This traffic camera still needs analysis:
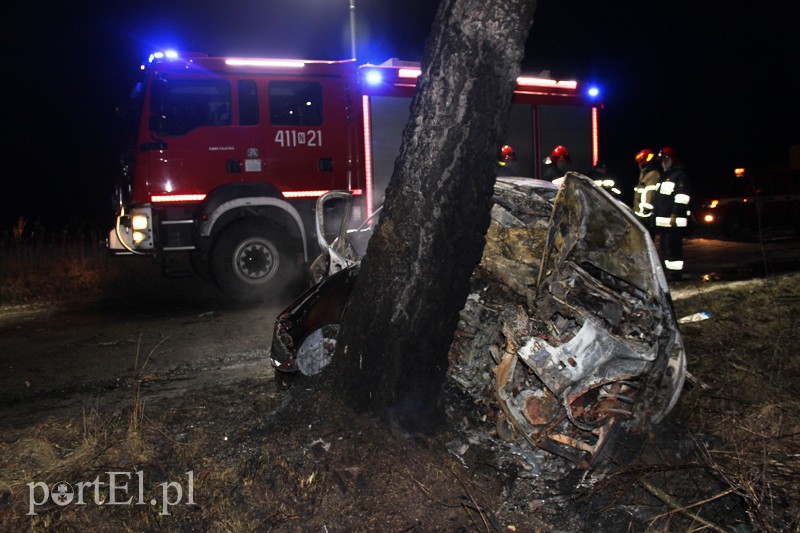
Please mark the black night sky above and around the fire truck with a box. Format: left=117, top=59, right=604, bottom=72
left=0, top=0, right=800, bottom=232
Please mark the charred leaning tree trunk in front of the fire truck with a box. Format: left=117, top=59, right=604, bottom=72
left=333, top=0, right=536, bottom=429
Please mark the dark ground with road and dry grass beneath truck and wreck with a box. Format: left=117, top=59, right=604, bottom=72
left=0, top=243, right=800, bottom=531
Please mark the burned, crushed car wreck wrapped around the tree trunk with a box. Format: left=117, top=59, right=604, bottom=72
left=271, top=173, right=686, bottom=467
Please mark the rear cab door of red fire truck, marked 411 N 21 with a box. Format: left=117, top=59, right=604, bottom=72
left=243, top=77, right=356, bottom=196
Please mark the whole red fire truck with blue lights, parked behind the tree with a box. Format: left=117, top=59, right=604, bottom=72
left=108, top=53, right=600, bottom=300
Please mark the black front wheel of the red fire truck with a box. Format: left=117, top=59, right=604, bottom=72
left=210, top=220, right=300, bottom=302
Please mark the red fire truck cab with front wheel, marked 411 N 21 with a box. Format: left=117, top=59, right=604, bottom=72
left=109, top=54, right=362, bottom=299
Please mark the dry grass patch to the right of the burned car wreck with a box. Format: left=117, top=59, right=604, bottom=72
left=676, top=275, right=800, bottom=531
